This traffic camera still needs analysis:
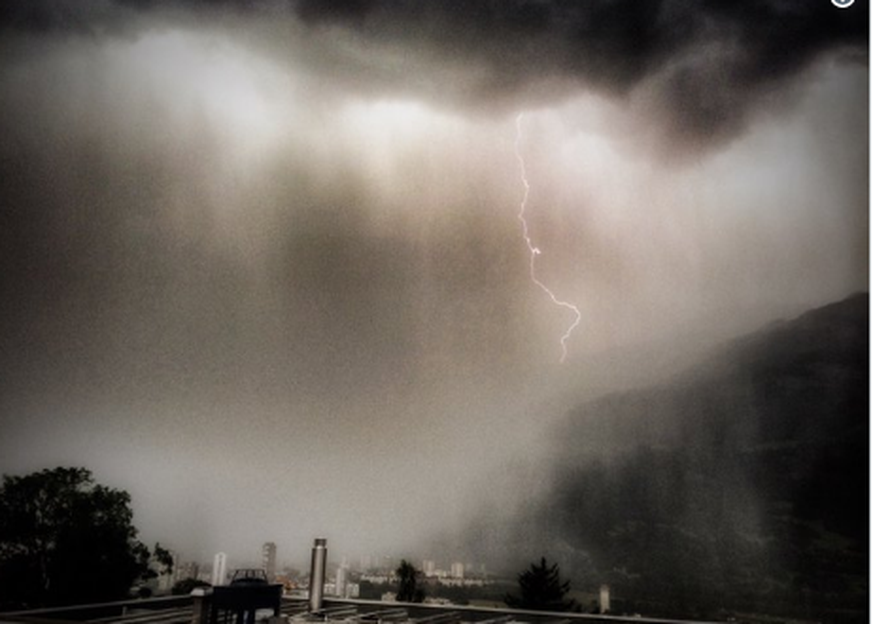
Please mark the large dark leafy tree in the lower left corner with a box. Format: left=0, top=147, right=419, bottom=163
left=0, top=468, right=154, bottom=610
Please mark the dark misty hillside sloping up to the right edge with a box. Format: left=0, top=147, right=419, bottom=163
left=480, top=294, right=869, bottom=621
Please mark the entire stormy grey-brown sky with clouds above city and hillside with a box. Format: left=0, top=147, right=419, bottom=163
left=0, top=0, right=869, bottom=567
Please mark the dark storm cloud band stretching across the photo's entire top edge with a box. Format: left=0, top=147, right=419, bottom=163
left=0, top=0, right=869, bottom=143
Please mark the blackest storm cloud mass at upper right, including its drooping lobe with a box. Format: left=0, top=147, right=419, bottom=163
left=288, top=0, right=869, bottom=141
